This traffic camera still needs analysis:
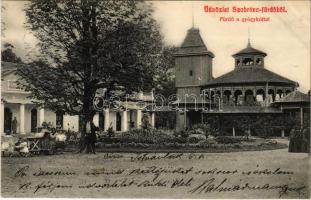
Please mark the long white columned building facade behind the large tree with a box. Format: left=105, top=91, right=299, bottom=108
left=0, top=62, right=155, bottom=134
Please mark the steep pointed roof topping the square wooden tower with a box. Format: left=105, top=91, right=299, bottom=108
left=175, top=28, right=215, bottom=58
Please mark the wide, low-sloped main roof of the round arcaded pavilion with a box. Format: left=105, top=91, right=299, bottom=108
left=207, top=67, right=298, bottom=86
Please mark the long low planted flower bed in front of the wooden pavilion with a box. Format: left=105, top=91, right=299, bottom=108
left=96, top=129, right=287, bottom=152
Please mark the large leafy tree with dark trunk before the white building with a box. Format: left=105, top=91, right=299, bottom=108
left=18, top=0, right=162, bottom=153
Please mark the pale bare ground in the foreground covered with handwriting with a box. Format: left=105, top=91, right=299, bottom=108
left=1, top=139, right=310, bottom=198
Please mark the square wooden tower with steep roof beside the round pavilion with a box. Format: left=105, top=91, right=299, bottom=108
left=174, top=27, right=214, bottom=128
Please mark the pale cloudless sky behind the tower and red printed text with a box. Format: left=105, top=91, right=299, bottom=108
left=1, top=1, right=311, bottom=92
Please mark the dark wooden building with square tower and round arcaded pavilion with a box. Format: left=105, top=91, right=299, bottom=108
left=175, top=28, right=310, bottom=134
